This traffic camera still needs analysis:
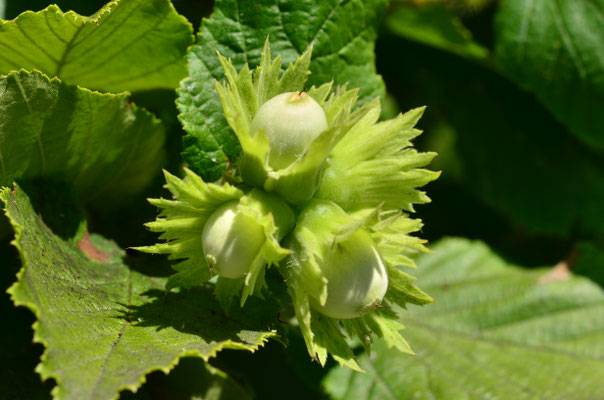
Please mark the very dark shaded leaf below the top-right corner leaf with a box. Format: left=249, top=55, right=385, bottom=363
left=448, top=67, right=604, bottom=237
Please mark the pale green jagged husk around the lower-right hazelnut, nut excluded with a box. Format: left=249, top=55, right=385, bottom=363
left=280, top=200, right=433, bottom=370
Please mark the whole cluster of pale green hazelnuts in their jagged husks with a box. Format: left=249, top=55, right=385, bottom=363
left=139, top=40, right=438, bottom=369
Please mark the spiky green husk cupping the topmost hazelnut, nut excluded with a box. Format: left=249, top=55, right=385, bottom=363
left=215, top=39, right=376, bottom=204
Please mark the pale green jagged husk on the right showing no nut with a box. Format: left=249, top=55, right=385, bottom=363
left=315, top=102, right=440, bottom=212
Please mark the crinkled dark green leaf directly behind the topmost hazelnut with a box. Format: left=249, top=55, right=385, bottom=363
left=177, top=0, right=385, bottom=181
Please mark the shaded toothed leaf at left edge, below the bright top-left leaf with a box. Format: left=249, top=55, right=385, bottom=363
left=0, top=70, right=164, bottom=202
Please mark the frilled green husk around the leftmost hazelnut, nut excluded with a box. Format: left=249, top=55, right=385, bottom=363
left=135, top=169, right=294, bottom=311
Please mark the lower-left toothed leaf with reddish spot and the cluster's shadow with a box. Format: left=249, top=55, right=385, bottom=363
left=0, top=186, right=278, bottom=400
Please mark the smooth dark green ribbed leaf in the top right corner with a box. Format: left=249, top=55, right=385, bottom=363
left=495, top=0, right=604, bottom=150
